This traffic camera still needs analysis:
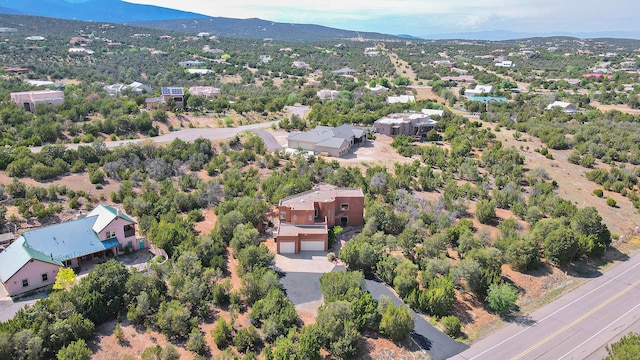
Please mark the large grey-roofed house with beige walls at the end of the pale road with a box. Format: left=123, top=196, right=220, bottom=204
left=287, top=124, right=367, bottom=157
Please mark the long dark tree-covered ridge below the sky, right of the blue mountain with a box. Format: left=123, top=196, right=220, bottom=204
left=128, top=17, right=406, bottom=41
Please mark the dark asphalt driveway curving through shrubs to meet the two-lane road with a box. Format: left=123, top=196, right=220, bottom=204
left=366, top=280, right=468, bottom=360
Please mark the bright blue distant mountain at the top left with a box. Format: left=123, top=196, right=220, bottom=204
left=0, top=0, right=205, bottom=23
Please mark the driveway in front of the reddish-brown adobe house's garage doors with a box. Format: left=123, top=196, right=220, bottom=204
left=275, top=252, right=344, bottom=314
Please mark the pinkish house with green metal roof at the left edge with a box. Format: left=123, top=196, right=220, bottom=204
left=0, top=205, right=139, bottom=296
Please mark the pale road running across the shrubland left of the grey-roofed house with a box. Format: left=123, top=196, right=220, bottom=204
left=31, top=121, right=278, bottom=153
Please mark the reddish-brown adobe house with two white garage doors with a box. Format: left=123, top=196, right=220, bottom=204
left=275, top=184, right=364, bottom=254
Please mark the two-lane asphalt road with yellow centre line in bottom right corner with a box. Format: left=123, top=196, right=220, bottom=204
left=453, top=254, right=640, bottom=360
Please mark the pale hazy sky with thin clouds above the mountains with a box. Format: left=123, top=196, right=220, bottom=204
left=125, top=0, right=640, bottom=36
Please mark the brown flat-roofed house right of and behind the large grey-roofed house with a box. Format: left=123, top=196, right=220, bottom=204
left=373, top=113, right=439, bottom=137
